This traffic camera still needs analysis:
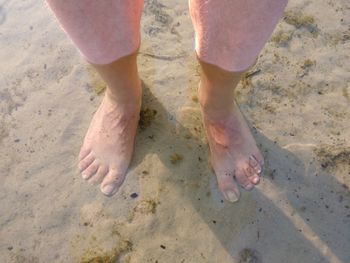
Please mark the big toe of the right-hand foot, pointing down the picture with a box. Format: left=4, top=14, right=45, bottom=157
left=216, top=173, right=240, bottom=203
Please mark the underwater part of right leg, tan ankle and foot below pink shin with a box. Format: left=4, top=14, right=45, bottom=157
left=199, top=62, right=264, bottom=202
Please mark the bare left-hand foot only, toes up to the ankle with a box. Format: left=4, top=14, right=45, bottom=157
left=79, top=92, right=140, bottom=196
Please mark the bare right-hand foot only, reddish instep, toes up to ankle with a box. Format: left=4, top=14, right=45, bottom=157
left=202, top=94, right=264, bottom=202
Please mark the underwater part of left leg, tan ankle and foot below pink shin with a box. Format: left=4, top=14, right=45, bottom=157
left=79, top=53, right=141, bottom=195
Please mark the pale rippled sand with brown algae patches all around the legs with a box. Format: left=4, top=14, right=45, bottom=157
left=0, top=0, right=350, bottom=263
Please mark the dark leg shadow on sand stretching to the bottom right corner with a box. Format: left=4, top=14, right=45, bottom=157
left=132, top=84, right=350, bottom=262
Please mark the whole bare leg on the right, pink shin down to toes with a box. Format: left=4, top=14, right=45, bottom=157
left=189, top=0, right=288, bottom=202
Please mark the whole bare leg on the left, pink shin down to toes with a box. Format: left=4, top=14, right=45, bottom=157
left=47, top=0, right=143, bottom=195
